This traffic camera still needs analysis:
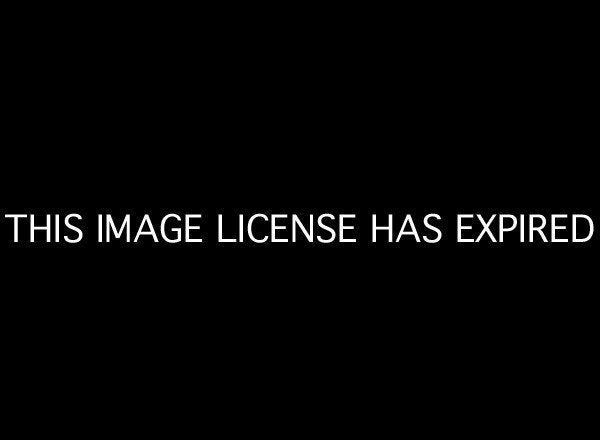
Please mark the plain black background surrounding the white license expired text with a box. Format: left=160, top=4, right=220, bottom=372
left=1, top=5, right=598, bottom=433
